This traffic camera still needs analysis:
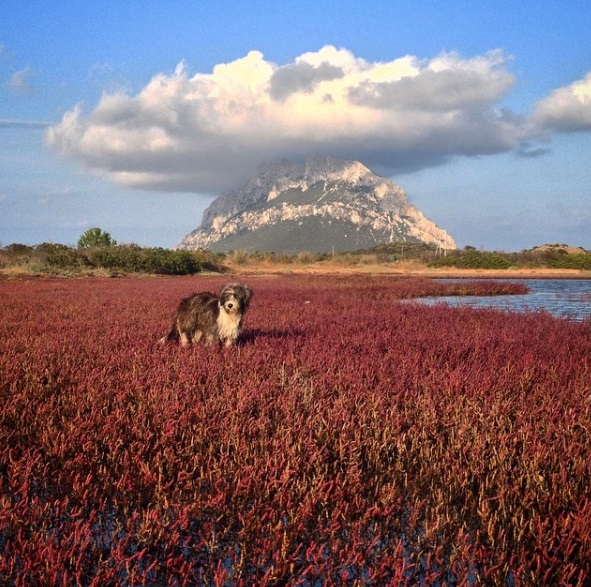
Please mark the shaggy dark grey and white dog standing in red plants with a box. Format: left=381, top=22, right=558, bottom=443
left=160, top=283, right=253, bottom=348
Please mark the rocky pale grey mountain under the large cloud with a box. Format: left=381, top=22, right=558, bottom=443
left=177, top=157, right=456, bottom=253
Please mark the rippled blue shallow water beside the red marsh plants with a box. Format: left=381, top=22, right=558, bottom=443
left=416, top=279, right=591, bottom=321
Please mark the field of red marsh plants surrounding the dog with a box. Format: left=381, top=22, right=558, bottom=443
left=0, top=276, right=591, bottom=586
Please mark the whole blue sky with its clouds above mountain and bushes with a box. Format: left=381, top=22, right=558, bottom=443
left=0, top=0, right=591, bottom=251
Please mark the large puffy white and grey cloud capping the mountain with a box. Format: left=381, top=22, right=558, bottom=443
left=45, top=46, right=568, bottom=193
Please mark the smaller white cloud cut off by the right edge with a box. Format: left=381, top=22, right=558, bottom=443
left=534, top=72, right=591, bottom=132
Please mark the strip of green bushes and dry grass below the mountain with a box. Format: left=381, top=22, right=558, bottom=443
left=0, top=228, right=591, bottom=276
